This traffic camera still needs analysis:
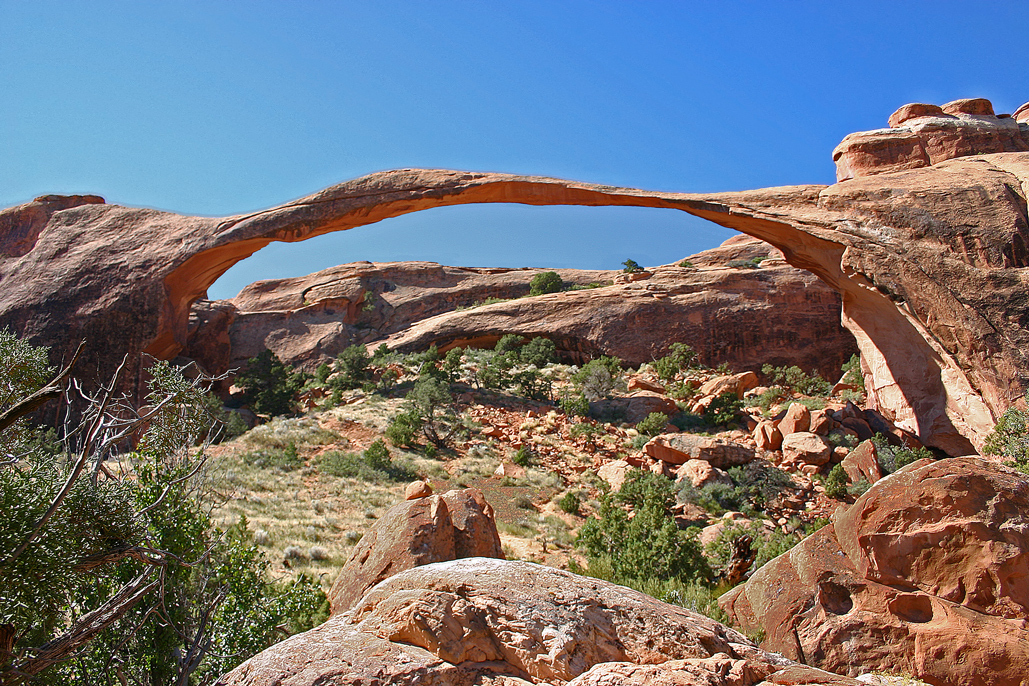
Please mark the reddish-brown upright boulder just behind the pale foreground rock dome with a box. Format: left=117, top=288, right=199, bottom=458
left=328, top=483, right=504, bottom=614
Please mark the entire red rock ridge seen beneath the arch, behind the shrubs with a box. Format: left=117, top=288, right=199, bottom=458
left=182, top=237, right=857, bottom=376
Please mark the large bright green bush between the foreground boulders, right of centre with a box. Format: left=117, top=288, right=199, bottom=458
left=575, top=470, right=711, bottom=583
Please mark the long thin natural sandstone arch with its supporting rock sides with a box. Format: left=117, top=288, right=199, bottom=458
left=0, top=97, right=1029, bottom=455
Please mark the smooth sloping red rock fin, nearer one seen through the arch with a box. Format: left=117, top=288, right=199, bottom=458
left=376, top=254, right=853, bottom=376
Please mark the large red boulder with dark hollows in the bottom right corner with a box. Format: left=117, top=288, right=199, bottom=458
left=720, top=458, right=1029, bottom=686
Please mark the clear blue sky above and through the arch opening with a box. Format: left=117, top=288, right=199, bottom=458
left=0, top=0, right=1029, bottom=297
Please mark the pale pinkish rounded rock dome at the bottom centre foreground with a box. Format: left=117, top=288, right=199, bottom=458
left=218, top=557, right=857, bottom=686
